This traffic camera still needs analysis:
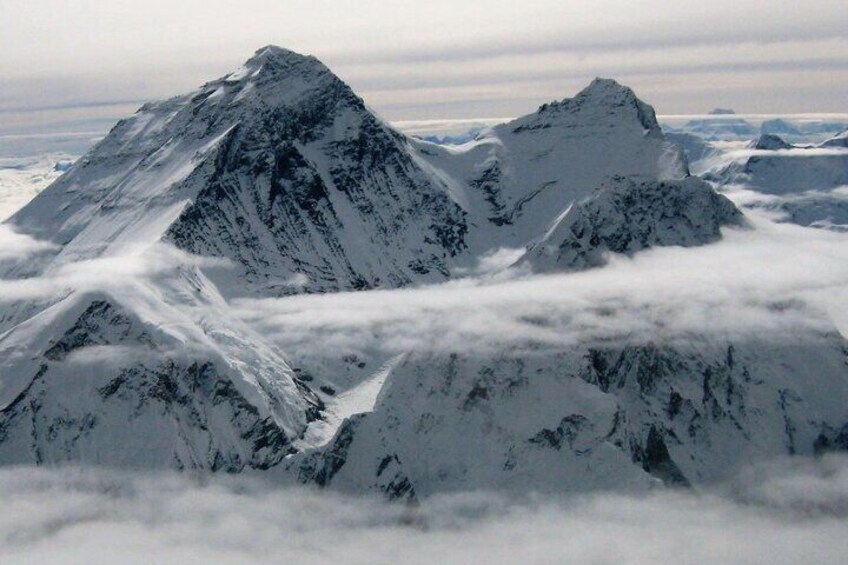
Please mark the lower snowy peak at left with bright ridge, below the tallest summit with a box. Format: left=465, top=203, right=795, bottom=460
left=0, top=273, right=321, bottom=472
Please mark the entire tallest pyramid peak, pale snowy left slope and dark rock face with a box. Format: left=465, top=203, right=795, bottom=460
left=6, top=47, right=465, bottom=293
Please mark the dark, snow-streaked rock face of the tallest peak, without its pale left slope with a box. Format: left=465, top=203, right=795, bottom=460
left=159, top=49, right=467, bottom=293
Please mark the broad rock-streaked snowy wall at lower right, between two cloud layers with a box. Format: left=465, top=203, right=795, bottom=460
left=286, top=333, right=848, bottom=498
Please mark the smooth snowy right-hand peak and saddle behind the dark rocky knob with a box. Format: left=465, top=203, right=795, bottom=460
left=416, top=79, right=688, bottom=252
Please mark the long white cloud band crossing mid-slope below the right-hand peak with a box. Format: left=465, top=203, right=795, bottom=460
left=233, top=217, right=848, bottom=356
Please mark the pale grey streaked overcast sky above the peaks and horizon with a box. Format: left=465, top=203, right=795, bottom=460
left=0, top=0, right=848, bottom=132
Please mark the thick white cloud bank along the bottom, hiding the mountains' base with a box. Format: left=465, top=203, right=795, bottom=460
left=0, top=456, right=848, bottom=565
